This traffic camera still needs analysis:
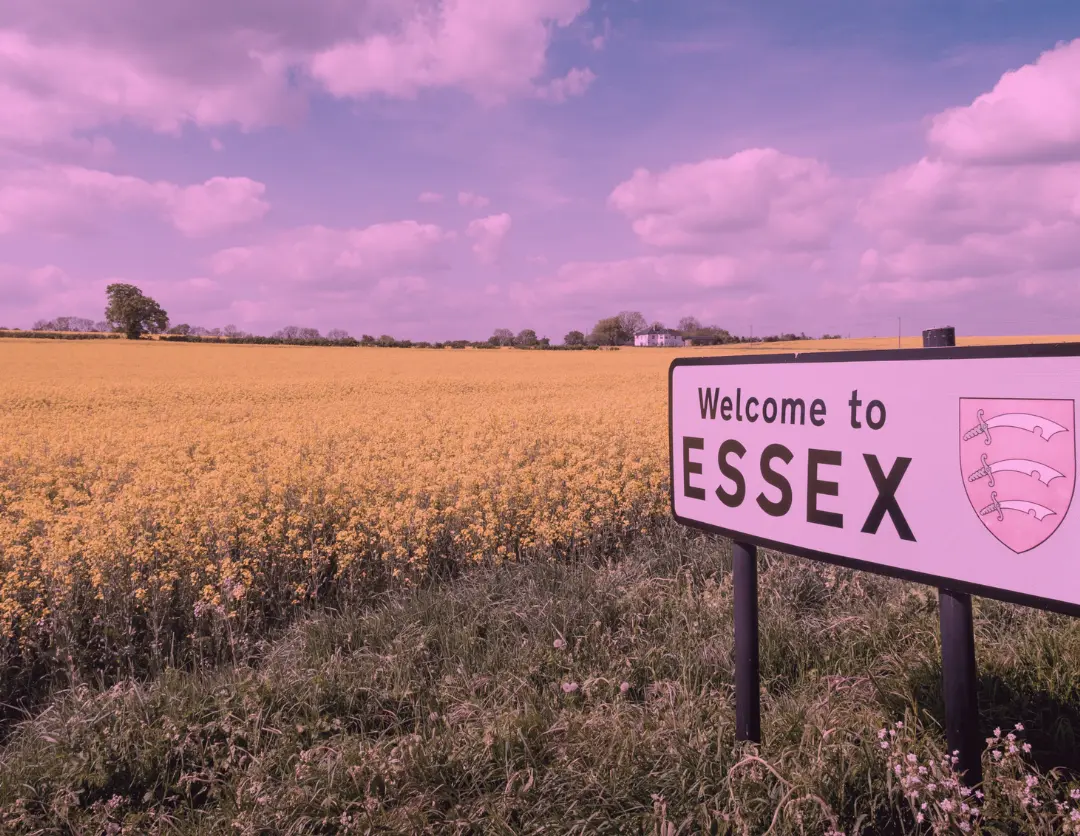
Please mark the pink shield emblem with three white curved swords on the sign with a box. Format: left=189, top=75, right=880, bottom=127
left=958, top=397, right=1077, bottom=554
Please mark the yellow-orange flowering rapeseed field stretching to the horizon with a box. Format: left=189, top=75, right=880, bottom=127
left=0, top=339, right=1071, bottom=686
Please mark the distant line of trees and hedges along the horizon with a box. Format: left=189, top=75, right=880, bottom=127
left=8, top=283, right=840, bottom=350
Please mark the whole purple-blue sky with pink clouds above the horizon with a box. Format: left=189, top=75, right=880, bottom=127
left=0, top=0, right=1080, bottom=342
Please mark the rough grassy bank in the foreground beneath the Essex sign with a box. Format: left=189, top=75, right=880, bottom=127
left=0, top=524, right=1080, bottom=836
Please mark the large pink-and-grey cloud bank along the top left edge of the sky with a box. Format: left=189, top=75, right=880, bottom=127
left=0, top=0, right=589, bottom=149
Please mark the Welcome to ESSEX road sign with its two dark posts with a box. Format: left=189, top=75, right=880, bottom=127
left=669, top=336, right=1080, bottom=783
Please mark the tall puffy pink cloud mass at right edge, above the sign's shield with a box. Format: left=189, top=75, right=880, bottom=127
left=858, top=40, right=1080, bottom=298
